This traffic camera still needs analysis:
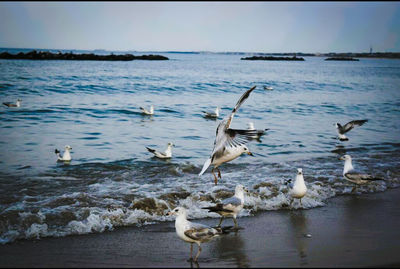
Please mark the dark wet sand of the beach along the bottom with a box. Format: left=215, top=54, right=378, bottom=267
left=0, top=188, right=400, bottom=268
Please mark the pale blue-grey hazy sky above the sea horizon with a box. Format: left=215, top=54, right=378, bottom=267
left=0, top=1, right=400, bottom=53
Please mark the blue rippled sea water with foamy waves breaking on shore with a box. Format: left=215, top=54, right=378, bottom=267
left=0, top=53, right=400, bottom=243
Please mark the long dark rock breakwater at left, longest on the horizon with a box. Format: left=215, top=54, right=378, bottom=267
left=0, top=50, right=169, bottom=61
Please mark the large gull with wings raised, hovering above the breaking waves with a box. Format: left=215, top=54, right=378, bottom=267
left=199, top=86, right=257, bottom=185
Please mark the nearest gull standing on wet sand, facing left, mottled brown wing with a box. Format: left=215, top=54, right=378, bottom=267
left=167, top=207, right=230, bottom=262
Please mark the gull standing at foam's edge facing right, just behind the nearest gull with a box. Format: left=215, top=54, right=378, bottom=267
left=203, top=184, right=249, bottom=229
